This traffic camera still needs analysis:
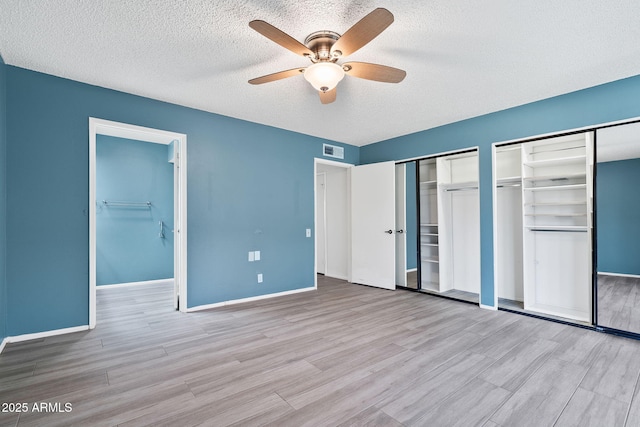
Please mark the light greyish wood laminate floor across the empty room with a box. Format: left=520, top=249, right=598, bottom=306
left=0, top=276, right=640, bottom=427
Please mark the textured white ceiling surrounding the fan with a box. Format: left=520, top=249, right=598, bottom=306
left=0, top=0, right=640, bottom=145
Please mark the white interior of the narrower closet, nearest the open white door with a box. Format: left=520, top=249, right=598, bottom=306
left=418, top=151, right=480, bottom=302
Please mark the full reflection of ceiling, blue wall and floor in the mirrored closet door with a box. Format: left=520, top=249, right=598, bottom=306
left=596, top=123, right=640, bottom=333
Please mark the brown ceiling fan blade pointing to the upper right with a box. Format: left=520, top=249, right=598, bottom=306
left=331, top=7, right=393, bottom=57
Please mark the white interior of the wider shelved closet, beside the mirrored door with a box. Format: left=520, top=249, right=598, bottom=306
left=495, top=133, right=593, bottom=322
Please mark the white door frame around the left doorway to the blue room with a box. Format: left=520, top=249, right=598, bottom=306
left=89, top=117, right=187, bottom=329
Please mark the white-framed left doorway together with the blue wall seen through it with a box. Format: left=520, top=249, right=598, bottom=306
left=88, top=118, right=187, bottom=328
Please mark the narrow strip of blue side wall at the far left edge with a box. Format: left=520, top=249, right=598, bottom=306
left=0, top=56, right=8, bottom=343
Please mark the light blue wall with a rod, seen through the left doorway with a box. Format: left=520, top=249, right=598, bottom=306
left=96, top=135, right=174, bottom=286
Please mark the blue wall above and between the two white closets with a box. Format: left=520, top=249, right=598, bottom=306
left=360, top=76, right=640, bottom=306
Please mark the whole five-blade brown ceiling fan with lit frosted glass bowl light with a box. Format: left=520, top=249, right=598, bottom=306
left=249, top=8, right=407, bottom=104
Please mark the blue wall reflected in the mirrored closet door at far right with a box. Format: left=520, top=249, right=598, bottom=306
left=596, top=159, right=640, bottom=275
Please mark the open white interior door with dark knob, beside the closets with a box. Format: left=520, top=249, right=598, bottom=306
left=351, top=162, right=396, bottom=289
